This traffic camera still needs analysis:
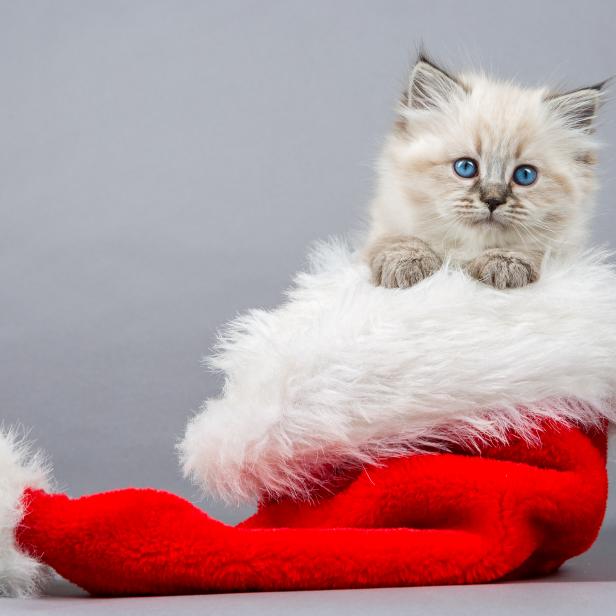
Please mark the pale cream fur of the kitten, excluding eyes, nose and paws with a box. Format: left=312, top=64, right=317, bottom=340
left=368, top=70, right=600, bottom=262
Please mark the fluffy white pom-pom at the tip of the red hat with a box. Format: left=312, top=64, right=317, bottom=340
left=0, top=430, right=50, bottom=597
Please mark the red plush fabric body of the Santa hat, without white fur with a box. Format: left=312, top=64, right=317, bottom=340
left=16, top=426, right=607, bottom=595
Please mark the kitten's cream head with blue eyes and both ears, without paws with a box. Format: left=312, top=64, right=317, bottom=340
left=382, top=61, right=599, bottom=255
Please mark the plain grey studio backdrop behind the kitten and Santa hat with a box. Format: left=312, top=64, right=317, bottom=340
left=0, top=0, right=616, bottom=520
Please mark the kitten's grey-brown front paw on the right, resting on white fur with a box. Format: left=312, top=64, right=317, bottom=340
left=467, top=249, right=539, bottom=289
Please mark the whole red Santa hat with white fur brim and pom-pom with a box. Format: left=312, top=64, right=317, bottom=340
left=0, top=247, right=616, bottom=595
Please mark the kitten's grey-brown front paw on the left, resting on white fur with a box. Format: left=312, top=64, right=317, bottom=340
left=365, top=235, right=443, bottom=288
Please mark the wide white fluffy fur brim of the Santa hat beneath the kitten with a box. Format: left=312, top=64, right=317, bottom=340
left=179, top=238, right=616, bottom=502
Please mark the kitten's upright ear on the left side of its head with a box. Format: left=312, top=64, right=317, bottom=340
left=402, top=54, right=466, bottom=111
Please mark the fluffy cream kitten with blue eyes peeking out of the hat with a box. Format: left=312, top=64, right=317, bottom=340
left=364, top=55, right=603, bottom=288
